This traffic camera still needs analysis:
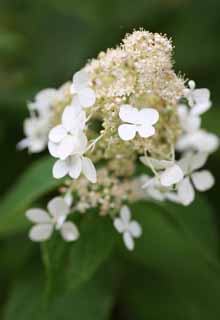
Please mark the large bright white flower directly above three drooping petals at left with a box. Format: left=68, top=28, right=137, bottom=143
left=48, top=106, right=87, bottom=160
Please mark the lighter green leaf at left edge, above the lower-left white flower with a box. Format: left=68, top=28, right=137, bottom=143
left=0, top=158, right=60, bottom=236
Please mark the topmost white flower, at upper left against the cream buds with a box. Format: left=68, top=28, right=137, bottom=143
left=70, top=70, right=96, bottom=108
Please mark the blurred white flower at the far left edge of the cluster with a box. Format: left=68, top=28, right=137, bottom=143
left=17, top=117, right=49, bottom=153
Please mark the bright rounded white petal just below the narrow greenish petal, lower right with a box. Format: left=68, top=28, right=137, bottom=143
left=160, top=164, right=183, bottom=187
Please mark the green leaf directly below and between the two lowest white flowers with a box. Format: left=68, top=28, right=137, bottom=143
left=43, top=211, right=115, bottom=295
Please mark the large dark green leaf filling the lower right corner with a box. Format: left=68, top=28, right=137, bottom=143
left=120, top=199, right=220, bottom=320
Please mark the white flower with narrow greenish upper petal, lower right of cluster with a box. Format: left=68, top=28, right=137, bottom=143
left=140, top=157, right=183, bottom=188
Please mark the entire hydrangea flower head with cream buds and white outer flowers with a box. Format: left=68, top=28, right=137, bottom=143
left=18, top=30, right=219, bottom=250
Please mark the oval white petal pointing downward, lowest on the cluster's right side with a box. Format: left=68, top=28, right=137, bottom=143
left=177, top=177, right=195, bottom=206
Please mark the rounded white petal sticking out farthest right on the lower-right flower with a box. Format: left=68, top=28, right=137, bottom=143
left=192, top=170, right=215, bottom=191
